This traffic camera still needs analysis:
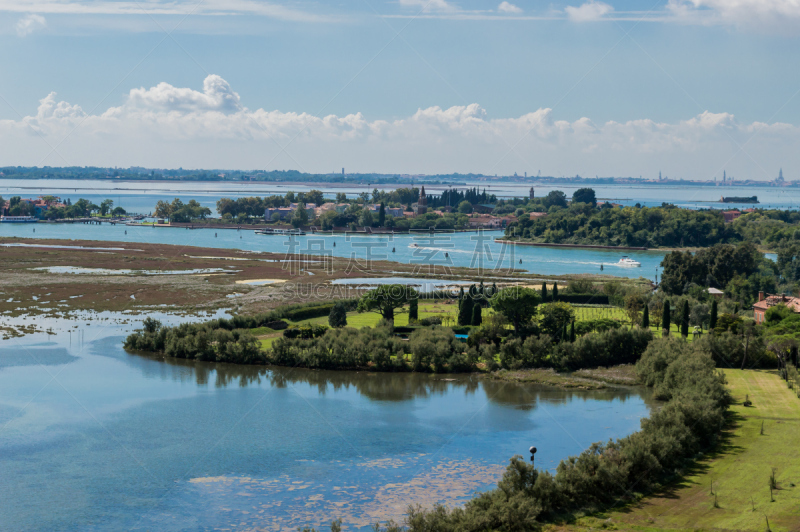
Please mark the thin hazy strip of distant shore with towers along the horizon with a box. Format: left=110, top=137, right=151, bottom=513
left=0, top=166, right=800, bottom=187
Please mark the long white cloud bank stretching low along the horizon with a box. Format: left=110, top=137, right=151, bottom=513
left=0, top=76, right=800, bottom=179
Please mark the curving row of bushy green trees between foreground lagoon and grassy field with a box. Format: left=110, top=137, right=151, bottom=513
left=310, top=338, right=731, bottom=532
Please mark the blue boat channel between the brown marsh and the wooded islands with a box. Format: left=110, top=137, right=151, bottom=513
left=0, top=223, right=664, bottom=279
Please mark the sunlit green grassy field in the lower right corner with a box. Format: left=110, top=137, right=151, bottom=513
left=564, top=370, right=800, bottom=532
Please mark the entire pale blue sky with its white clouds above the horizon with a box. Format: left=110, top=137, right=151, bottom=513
left=0, top=0, right=800, bottom=179
